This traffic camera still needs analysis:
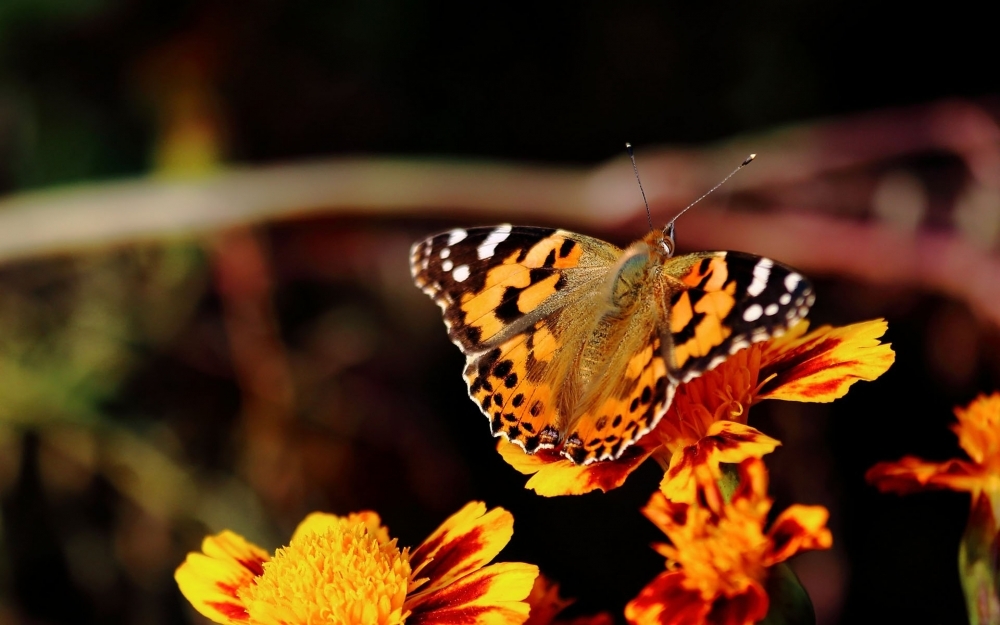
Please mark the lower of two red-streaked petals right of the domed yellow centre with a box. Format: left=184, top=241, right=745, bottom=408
left=406, top=562, right=538, bottom=625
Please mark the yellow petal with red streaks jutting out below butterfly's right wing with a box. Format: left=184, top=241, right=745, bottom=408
left=757, top=319, right=896, bottom=402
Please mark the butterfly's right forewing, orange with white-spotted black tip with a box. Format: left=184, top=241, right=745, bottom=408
left=664, top=252, right=815, bottom=382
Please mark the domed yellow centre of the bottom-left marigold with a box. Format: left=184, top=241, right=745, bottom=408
left=240, top=519, right=410, bottom=625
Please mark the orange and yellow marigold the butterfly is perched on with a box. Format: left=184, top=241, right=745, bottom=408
left=497, top=319, right=895, bottom=497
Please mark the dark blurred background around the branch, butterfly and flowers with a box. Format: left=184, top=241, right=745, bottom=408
left=0, top=0, right=1000, bottom=624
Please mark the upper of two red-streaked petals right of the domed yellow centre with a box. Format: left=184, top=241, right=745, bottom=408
left=410, top=501, right=512, bottom=596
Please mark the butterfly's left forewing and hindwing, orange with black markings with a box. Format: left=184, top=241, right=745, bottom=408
left=410, top=225, right=621, bottom=453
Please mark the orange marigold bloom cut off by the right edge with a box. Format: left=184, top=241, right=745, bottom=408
left=866, top=393, right=1000, bottom=510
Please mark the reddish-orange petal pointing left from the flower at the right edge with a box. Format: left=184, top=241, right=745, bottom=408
left=865, top=456, right=989, bottom=494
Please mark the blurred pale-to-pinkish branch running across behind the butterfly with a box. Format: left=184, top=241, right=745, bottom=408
left=0, top=102, right=1000, bottom=323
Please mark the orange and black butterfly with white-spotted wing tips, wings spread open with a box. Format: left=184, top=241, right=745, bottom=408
left=410, top=222, right=814, bottom=464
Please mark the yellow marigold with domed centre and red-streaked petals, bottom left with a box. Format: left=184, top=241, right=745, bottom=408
left=174, top=502, right=538, bottom=625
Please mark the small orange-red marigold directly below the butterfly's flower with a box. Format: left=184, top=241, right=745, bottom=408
left=625, top=458, right=833, bottom=625
